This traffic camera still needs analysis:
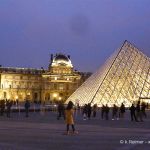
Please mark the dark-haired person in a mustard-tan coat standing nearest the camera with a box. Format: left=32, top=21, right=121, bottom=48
left=65, top=101, right=75, bottom=134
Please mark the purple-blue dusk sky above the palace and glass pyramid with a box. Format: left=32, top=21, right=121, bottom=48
left=0, top=0, right=150, bottom=72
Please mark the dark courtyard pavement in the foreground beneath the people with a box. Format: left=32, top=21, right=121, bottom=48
left=0, top=111, right=150, bottom=150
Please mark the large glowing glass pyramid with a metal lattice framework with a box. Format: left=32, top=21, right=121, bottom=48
left=66, top=41, right=150, bottom=107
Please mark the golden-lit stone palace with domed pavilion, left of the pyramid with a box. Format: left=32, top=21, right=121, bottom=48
left=0, top=54, right=81, bottom=102
